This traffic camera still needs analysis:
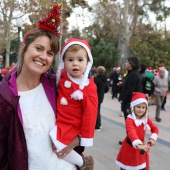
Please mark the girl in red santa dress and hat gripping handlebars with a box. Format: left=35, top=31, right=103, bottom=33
left=116, top=92, right=158, bottom=170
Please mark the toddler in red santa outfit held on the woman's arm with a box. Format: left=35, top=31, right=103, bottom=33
left=50, top=38, right=98, bottom=170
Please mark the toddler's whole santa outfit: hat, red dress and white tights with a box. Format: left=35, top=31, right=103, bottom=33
left=50, top=38, right=98, bottom=166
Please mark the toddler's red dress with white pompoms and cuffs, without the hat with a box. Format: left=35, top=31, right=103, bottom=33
left=56, top=70, right=98, bottom=146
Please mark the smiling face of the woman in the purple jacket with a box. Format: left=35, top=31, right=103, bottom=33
left=22, top=36, right=54, bottom=75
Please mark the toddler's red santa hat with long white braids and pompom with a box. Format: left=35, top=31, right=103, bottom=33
left=56, top=38, right=93, bottom=100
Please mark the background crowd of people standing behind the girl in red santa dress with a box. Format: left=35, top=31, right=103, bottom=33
left=110, top=61, right=169, bottom=122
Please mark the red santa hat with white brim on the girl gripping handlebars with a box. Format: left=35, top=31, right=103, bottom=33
left=130, top=92, right=148, bottom=108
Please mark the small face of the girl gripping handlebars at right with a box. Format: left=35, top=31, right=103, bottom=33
left=134, top=103, right=147, bottom=119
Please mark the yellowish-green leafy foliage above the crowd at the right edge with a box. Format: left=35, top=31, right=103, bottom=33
left=129, top=25, right=170, bottom=69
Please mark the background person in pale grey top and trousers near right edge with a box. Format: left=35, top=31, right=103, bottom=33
left=153, top=67, right=168, bottom=122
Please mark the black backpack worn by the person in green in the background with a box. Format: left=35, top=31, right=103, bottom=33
left=143, top=77, right=155, bottom=94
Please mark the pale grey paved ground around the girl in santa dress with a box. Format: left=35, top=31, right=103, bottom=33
left=85, top=89, right=170, bottom=170
